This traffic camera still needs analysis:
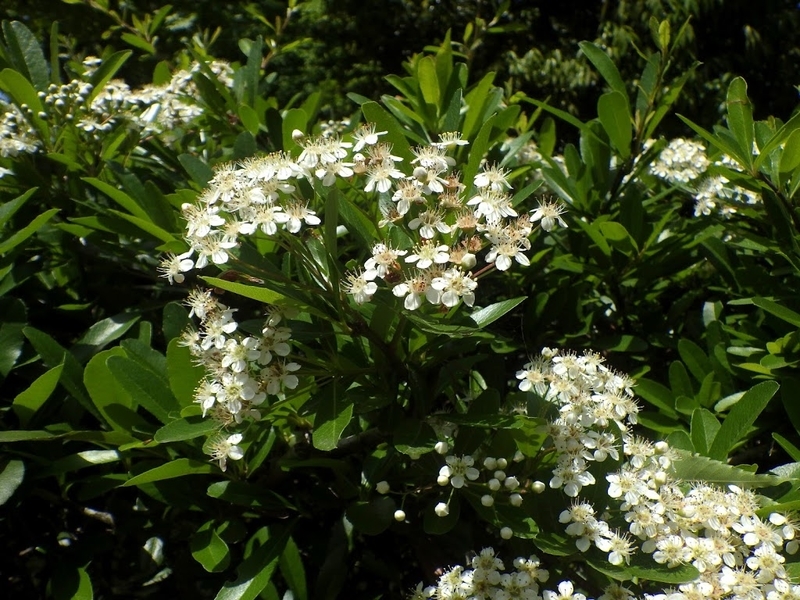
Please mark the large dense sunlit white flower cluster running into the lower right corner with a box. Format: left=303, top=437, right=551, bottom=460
left=517, top=349, right=800, bottom=600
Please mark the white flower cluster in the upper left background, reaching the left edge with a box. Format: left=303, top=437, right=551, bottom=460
left=0, top=57, right=233, bottom=157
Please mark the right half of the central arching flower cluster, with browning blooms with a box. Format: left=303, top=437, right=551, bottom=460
left=345, top=129, right=566, bottom=310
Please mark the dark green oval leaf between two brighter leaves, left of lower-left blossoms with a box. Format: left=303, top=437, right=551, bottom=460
left=106, top=356, right=181, bottom=424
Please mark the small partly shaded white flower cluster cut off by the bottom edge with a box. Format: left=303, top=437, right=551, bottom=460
left=409, top=548, right=552, bottom=600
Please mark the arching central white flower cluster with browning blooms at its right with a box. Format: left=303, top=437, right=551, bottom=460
left=161, top=124, right=566, bottom=310
